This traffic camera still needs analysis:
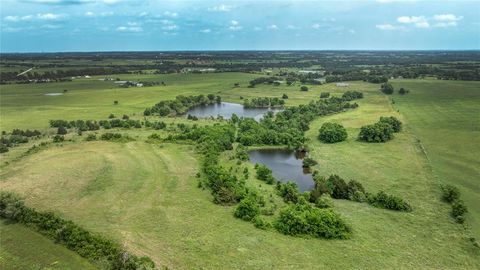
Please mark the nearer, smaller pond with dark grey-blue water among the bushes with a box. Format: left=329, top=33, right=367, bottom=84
left=248, top=149, right=314, bottom=192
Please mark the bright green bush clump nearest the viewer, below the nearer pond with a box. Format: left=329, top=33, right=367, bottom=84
left=275, top=203, right=351, bottom=239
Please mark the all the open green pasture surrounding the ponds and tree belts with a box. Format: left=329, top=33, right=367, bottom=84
left=0, top=51, right=480, bottom=269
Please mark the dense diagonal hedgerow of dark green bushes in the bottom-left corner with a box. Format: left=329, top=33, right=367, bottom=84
left=0, top=191, right=155, bottom=270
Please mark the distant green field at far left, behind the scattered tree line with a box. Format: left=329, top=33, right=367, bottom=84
left=0, top=73, right=256, bottom=131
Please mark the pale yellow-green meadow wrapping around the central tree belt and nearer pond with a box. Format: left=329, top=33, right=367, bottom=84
left=0, top=79, right=480, bottom=269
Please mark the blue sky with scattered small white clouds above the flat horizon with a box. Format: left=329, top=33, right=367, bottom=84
left=0, top=0, right=480, bottom=52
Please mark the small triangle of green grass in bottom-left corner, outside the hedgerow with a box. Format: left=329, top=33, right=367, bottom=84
left=0, top=220, right=96, bottom=270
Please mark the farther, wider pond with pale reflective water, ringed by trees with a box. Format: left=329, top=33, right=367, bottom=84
left=187, top=102, right=277, bottom=121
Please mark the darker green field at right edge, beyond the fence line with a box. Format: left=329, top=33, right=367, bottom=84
left=392, top=80, right=480, bottom=238
